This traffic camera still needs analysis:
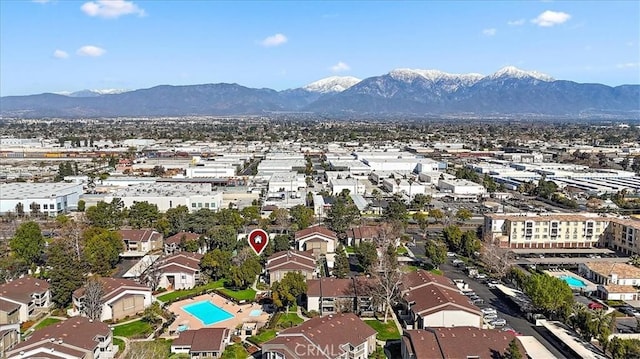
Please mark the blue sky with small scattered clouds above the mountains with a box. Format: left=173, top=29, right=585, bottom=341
left=0, top=0, right=640, bottom=96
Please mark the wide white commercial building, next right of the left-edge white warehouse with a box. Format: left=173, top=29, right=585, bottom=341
left=104, top=182, right=223, bottom=212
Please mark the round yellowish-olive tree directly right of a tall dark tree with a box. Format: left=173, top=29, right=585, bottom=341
left=82, top=227, right=124, bottom=276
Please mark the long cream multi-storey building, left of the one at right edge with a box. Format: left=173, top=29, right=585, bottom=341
left=484, top=213, right=611, bottom=248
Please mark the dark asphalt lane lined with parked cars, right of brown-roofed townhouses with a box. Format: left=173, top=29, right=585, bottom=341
left=440, top=259, right=566, bottom=358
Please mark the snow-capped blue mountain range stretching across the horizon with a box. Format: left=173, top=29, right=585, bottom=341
left=0, top=66, right=640, bottom=119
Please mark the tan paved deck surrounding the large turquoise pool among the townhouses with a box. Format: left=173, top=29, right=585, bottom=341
left=168, top=294, right=269, bottom=333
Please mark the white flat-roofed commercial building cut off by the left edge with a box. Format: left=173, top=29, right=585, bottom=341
left=0, top=182, right=83, bottom=217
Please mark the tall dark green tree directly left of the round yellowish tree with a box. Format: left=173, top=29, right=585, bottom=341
left=47, top=237, right=86, bottom=308
